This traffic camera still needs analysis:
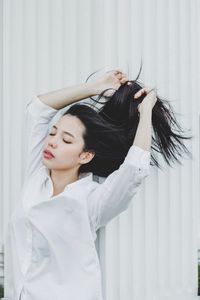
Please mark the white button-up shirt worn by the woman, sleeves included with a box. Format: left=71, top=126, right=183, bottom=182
left=3, top=97, right=150, bottom=300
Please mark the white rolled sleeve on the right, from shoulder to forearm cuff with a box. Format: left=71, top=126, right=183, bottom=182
left=88, top=145, right=150, bottom=230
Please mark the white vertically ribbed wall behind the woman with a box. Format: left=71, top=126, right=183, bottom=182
left=0, top=0, right=200, bottom=300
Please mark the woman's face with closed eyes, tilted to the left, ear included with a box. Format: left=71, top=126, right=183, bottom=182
left=43, top=114, right=93, bottom=170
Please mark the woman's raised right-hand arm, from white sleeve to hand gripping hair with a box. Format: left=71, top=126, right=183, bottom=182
left=88, top=86, right=157, bottom=231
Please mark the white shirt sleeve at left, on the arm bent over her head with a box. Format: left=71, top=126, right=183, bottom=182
left=24, top=96, right=58, bottom=180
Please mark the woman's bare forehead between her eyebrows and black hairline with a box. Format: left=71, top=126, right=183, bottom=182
left=53, top=114, right=85, bottom=138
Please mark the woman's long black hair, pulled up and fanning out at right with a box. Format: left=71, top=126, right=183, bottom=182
left=64, top=68, right=191, bottom=177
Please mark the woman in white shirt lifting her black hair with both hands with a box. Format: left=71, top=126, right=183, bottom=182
left=4, top=70, right=189, bottom=300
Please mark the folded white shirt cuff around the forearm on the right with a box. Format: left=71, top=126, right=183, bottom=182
left=124, top=145, right=151, bottom=169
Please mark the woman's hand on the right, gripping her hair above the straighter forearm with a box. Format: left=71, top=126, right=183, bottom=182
left=134, top=87, right=157, bottom=114
